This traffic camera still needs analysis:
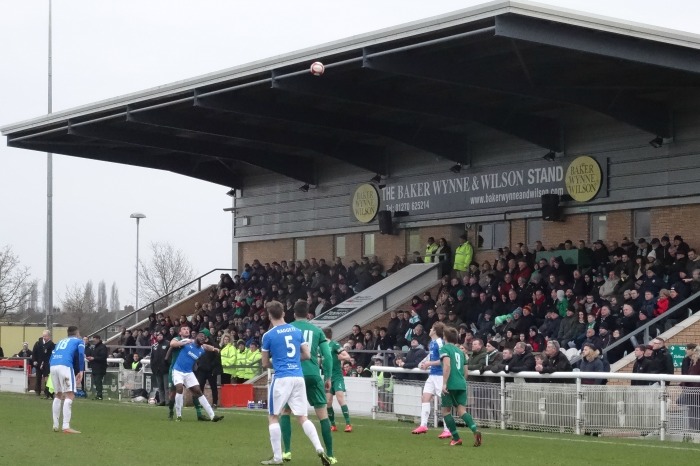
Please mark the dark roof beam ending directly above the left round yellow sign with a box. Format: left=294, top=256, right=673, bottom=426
left=127, top=105, right=387, bottom=175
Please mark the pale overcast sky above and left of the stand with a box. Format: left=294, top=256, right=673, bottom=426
left=0, top=0, right=700, bottom=307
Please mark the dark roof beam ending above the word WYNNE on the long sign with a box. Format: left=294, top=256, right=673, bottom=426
left=195, top=93, right=469, bottom=163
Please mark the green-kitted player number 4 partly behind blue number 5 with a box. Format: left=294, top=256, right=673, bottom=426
left=280, top=300, right=338, bottom=464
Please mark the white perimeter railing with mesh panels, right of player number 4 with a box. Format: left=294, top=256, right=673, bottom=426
left=282, top=366, right=700, bottom=443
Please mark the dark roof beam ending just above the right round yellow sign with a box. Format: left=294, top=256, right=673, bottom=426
left=363, top=45, right=671, bottom=137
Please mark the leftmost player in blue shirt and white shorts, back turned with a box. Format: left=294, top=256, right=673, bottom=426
left=49, top=325, right=85, bottom=434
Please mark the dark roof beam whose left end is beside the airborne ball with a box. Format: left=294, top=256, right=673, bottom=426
left=272, top=62, right=563, bottom=152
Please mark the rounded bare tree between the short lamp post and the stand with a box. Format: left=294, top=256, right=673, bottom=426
left=139, top=243, right=195, bottom=309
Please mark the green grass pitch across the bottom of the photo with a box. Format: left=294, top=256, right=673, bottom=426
left=0, top=393, right=700, bottom=466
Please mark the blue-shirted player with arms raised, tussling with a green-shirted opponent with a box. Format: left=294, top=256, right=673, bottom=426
left=170, top=333, right=224, bottom=422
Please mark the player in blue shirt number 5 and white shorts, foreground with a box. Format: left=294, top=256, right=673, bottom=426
left=261, top=301, right=331, bottom=466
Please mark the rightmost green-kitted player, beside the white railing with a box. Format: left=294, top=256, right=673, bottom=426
left=440, top=327, right=481, bottom=447
